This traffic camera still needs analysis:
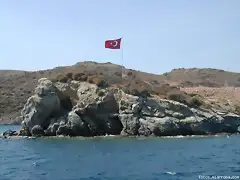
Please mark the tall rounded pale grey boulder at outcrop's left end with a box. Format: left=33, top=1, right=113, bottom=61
left=21, top=78, right=72, bottom=134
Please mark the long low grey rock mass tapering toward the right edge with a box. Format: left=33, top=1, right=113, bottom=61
left=119, top=94, right=240, bottom=136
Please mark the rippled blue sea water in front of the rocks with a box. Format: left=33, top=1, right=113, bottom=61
left=0, top=125, right=240, bottom=180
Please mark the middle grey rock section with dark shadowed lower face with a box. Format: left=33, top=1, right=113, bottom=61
left=73, top=82, right=122, bottom=136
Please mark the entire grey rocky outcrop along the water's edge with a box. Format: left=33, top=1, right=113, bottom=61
left=21, top=78, right=240, bottom=136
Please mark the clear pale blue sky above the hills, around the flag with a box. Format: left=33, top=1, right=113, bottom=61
left=0, top=0, right=240, bottom=74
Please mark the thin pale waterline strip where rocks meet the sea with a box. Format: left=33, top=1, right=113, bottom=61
left=0, top=133, right=240, bottom=140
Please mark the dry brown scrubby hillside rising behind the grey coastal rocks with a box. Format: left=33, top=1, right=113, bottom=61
left=0, top=62, right=240, bottom=123
